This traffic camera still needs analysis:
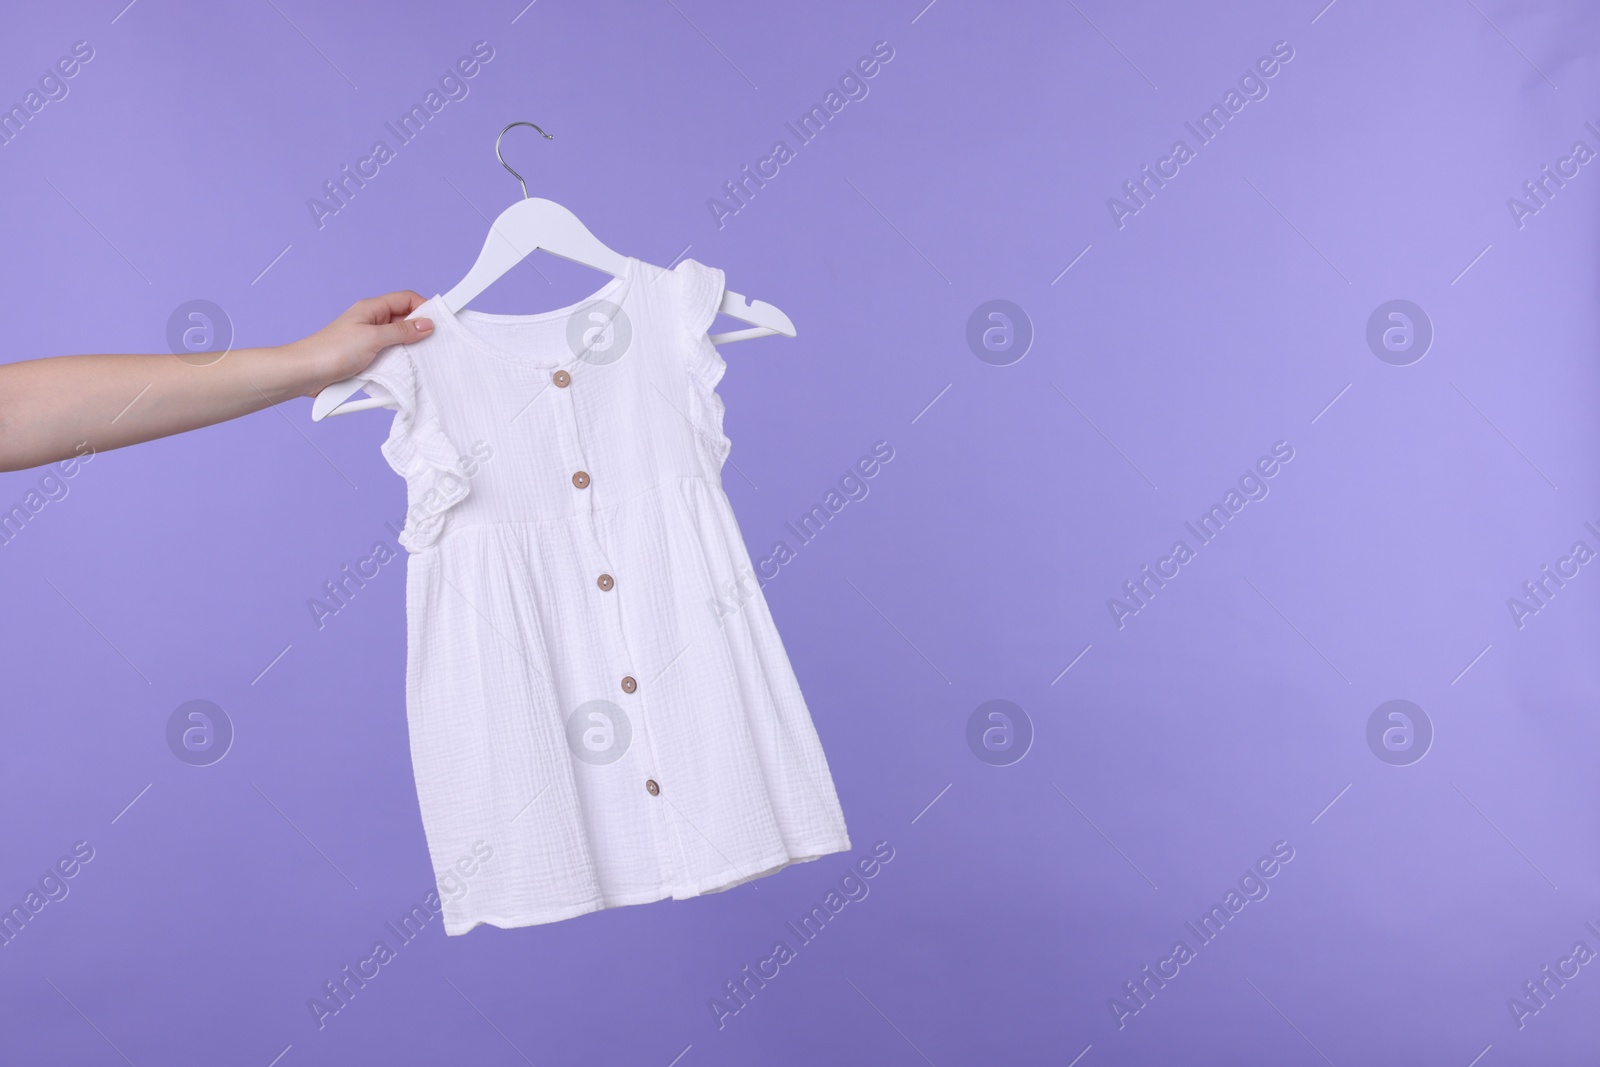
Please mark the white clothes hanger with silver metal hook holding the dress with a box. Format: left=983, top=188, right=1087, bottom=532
left=310, top=122, right=795, bottom=422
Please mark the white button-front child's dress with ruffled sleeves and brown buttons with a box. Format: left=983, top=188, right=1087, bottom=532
left=362, top=259, right=850, bottom=934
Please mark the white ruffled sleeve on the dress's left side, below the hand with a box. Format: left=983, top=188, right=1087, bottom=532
left=360, top=331, right=472, bottom=552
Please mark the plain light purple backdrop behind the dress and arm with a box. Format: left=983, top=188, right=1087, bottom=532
left=0, top=0, right=1600, bottom=1067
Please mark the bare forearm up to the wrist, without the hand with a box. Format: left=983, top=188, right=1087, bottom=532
left=0, top=344, right=322, bottom=470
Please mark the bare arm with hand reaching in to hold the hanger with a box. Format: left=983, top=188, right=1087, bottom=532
left=0, top=290, right=434, bottom=470
